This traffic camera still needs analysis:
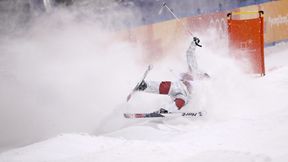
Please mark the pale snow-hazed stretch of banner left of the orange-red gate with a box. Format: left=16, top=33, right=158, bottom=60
left=122, top=12, right=227, bottom=59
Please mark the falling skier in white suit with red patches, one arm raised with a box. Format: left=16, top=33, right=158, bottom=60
left=128, top=37, right=209, bottom=114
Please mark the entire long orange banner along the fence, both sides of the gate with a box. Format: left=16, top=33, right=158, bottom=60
left=121, top=0, right=288, bottom=59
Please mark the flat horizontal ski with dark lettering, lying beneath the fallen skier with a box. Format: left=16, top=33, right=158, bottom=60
left=124, top=111, right=206, bottom=119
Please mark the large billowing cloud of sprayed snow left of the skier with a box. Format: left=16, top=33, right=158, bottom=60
left=0, top=6, right=143, bottom=151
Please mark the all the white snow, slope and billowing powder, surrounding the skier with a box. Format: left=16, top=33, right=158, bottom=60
left=0, top=7, right=288, bottom=162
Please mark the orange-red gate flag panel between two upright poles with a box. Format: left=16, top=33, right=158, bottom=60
left=227, top=11, right=265, bottom=76
